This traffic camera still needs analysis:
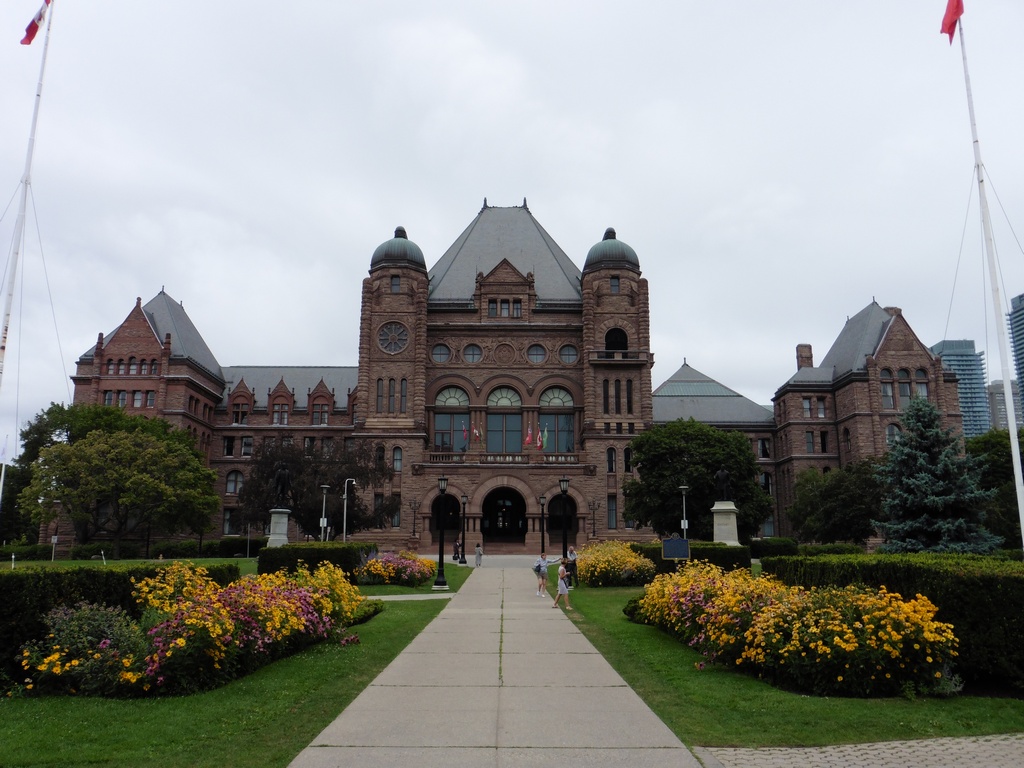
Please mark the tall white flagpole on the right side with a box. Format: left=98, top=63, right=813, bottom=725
left=957, top=19, right=1024, bottom=545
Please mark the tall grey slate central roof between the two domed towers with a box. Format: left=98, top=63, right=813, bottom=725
left=429, top=201, right=582, bottom=302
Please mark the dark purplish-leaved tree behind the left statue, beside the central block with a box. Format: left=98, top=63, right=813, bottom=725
left=239, top=439, right=398, bottom=538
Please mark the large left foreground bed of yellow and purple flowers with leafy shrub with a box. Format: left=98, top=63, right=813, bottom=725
left=22, top=563, right=362, bottom=695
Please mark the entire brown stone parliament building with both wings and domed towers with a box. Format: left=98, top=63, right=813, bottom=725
left=73, top=201, right=959, bottom=553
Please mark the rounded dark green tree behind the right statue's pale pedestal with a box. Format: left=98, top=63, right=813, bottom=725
left=623, top=419, right=772, bottom=541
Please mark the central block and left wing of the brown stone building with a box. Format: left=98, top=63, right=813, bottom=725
left=73, top=201, right=653, bottom=552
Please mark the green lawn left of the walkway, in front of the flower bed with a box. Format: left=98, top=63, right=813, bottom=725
left=0, top=602, right=447, bottom=768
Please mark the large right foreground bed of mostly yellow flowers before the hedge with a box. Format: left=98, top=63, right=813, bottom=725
left=637, top=562, right=956, bottom=696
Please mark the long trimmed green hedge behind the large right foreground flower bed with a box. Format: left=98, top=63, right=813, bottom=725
left=761, top=554, right=1024, bottom=690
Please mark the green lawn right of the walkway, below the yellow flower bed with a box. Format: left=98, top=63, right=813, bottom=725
left=568, top=588, right=1024, bottom=748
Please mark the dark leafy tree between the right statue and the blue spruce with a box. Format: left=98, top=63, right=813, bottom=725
left=786, top=459, right=882, bottom=545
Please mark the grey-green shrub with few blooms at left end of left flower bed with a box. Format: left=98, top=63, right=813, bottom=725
left=22, top=603, right=147, bottom=696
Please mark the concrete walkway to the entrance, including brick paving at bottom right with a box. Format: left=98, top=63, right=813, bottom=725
left=290, top=555, right=1024, bottom=768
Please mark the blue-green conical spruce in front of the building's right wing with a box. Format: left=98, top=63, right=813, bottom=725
left=876, top=397, right=1002, bottom=553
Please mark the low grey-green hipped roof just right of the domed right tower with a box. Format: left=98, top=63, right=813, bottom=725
left=652, top=361, right=774, bottom=427
